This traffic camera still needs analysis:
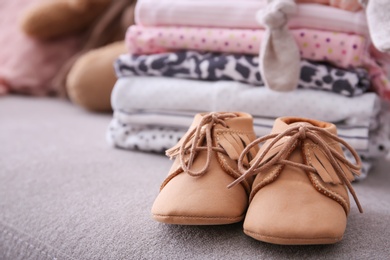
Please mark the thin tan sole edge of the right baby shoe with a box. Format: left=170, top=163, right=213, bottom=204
left=244, top=229, right=343, bottom=245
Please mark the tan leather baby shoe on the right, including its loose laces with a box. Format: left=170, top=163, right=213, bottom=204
left=230, top=117, right=362, bottom=245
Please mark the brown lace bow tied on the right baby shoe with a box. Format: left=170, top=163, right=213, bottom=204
left=228, top=124, right=363, bottom=213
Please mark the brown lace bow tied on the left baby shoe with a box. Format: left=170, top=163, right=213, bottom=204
left=166, top=112, right=237, bottom=177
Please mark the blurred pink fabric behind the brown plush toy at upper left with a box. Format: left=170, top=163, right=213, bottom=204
left=0, top=0, right=79, bottom=95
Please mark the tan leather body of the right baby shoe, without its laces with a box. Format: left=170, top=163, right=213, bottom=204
left=244, top=117, right=358, bottom=245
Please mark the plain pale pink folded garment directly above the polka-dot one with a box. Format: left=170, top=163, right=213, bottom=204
left=135, top=0, right=368, bottom=35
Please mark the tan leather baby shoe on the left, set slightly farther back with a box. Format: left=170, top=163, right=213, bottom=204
left=152, top=113, right=258, bottom=225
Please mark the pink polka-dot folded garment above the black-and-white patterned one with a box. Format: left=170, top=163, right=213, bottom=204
left=126, top=25, right=390, bottom=98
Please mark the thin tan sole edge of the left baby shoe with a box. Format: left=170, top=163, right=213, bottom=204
left=152, top=214, right=244, bottom=225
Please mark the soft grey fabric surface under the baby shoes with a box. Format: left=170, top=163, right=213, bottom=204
left=0, top=96, right=390, bottom=260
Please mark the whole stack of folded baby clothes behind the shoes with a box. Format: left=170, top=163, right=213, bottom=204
left=107, top=0, right=390, bottom=177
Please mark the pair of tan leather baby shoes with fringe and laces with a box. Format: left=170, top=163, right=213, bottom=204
left=152, top=112, right=362, bottom=245
